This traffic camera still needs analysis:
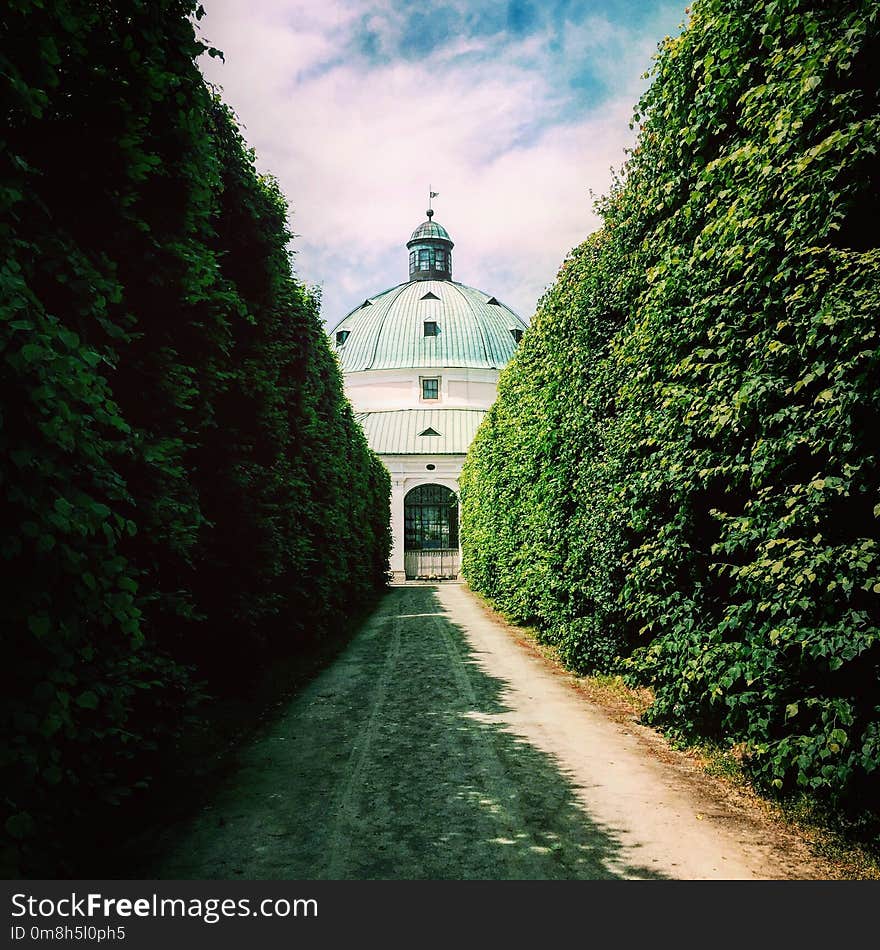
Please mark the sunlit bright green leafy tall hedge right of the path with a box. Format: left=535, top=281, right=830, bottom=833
left=462, top=0, right=880, bottom=809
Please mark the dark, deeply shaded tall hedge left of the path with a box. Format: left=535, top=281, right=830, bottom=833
left=0, top=0, right=390, bottom=872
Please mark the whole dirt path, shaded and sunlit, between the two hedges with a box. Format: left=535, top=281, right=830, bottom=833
left=147, top=584, right=820, bottom=880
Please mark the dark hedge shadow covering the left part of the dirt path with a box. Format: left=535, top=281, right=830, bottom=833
left=143, top=587, right=661, bottom=880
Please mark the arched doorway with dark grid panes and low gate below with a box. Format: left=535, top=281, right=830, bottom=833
left=403, top=485, right=459, bottom=580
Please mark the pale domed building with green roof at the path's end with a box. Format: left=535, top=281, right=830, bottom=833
left=331, top=209, right=526, bottom=580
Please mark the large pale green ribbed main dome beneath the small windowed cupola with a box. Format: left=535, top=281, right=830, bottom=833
left=332, top=278, right=526, bottom=373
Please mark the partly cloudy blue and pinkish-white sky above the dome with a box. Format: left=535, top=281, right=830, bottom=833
left=199, top=0, right=686, bottom=327
